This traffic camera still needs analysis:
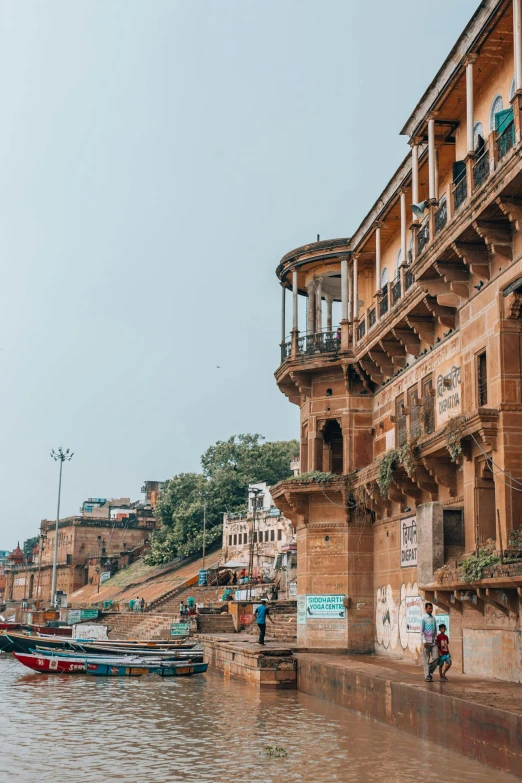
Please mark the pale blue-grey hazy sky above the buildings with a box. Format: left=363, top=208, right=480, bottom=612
left=0, top=0, right=478, bottom=549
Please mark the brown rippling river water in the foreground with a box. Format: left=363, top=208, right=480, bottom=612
left=0, top=654, right=517, bottom=783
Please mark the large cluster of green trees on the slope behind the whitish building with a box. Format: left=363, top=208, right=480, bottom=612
left=146, top=434, right=299, bottom=565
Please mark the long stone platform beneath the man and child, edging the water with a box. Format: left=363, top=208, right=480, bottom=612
left=296, top=652, right=522, bottom=778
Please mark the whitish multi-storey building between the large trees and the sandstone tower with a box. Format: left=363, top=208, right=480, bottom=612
left=223, top=482, right=295, bottom=578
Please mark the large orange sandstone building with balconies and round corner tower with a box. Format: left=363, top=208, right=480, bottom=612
left=272, top=0, right=522, bottom=682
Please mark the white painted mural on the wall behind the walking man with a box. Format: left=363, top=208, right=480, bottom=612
left=375, top=582, right=421, bottom=653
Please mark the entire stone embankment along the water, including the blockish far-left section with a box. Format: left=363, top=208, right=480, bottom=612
left=198, top=635, right=522, bottom=778
